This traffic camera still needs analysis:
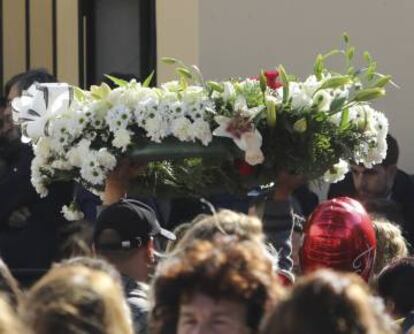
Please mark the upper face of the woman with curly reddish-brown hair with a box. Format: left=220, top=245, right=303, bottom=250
left=177, top=293, right=251, bottom=334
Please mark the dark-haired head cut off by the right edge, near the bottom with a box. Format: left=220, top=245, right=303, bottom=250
left=377, top=257, right=414, bottom=318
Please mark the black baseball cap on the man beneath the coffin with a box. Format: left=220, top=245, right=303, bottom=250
left=94, top=199, right=176, bottom=250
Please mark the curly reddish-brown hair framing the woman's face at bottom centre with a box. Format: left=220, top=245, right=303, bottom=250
left=150, top=240, right=280, bottom=334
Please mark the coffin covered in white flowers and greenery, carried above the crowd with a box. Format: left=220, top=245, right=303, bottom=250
left=13, top=38, right=390, bottom=200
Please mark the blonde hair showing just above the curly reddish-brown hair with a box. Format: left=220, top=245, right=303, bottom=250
left=176, top=210, right=264, bottom=248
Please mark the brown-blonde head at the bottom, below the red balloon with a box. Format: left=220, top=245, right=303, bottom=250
left=262, top=270, right=396, bottom=334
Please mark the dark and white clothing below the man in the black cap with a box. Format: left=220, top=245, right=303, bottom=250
left=122, top=275, right=149, bottom=334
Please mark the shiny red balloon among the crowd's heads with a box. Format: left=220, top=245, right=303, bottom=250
left=300, top=197, right=376, bottom=281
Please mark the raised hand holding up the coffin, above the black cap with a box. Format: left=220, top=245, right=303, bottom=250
left=103, top=159, right=145, bottom=205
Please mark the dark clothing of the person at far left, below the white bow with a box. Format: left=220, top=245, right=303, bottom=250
left=0, top=144, right=72, bottom=269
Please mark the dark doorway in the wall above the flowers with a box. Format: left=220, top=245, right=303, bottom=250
left=79, top=0, right=156, bottom=86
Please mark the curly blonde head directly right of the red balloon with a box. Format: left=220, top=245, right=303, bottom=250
left=373, top=219, right=408, bottom=274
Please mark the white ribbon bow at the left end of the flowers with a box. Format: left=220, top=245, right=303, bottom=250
left=12, top=83, right=72, bottom=141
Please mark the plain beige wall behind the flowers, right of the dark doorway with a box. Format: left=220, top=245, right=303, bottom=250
left=157, top=0, right=414, bottom=173
